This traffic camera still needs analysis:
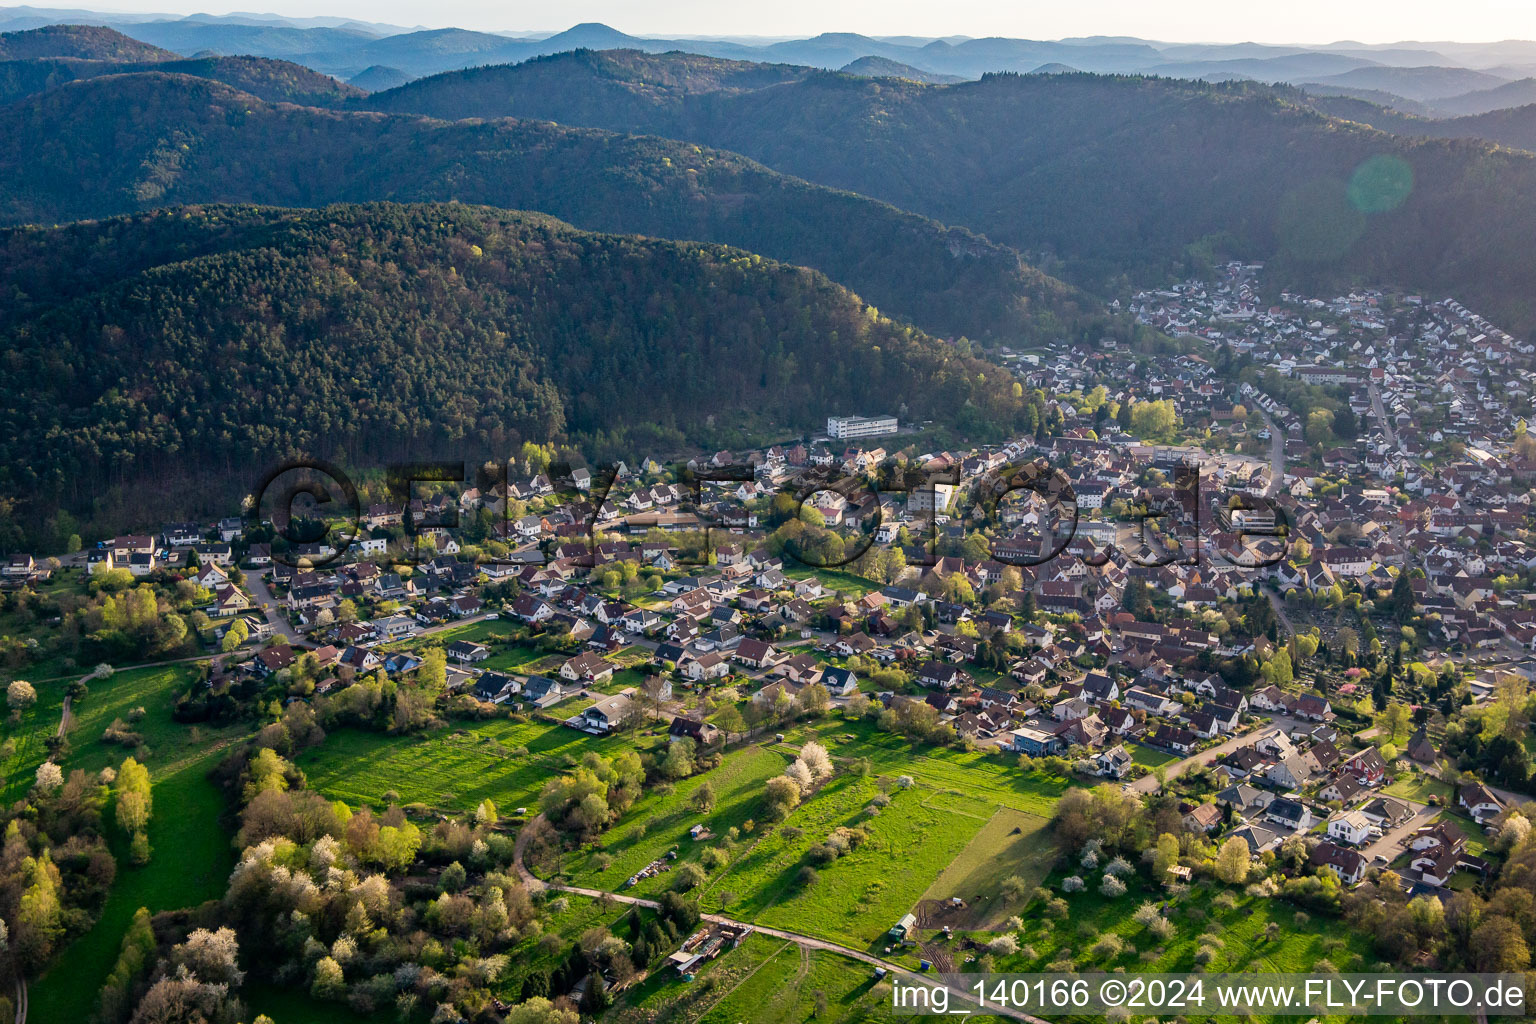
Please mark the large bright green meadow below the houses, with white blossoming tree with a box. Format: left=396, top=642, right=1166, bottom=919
left=564, top=718, right=1066, bottom=949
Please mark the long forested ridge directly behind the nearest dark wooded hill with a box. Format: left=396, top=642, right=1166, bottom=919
left=0, top=72, right=1097, bottom=342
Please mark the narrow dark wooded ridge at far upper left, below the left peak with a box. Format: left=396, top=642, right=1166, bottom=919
left=0, top=57, right=364, bottom=106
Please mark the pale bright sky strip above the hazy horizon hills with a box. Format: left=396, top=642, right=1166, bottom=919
left=59, top=0, right=1536, bottom=43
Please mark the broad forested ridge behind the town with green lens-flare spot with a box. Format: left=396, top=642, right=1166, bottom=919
left=366, top=51, right=1536, bottom=330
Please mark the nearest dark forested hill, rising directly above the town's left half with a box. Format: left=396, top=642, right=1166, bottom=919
left=0, top=204, right=1040, bottom=534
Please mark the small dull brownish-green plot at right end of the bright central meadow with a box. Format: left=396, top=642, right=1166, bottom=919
left=923, top=808, right=1055, bottom=929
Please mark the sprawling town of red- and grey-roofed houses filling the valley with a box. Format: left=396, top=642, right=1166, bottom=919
left=3, top=264, right=1536, bottom=1019
